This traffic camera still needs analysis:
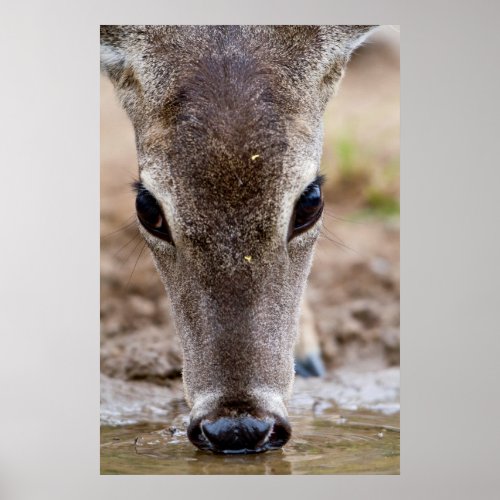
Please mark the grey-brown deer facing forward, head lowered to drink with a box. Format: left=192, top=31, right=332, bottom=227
left=100, top=25, right=374, bottom=454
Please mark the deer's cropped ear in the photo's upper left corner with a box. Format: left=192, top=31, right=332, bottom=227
left=101, top=25, right=127, bottom=81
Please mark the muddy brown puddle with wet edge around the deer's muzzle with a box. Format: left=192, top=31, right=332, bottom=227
left=101, top=370, right=400, bottom=474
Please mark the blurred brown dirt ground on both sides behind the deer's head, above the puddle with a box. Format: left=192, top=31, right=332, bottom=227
left=101, top=29, right=400, bottom=384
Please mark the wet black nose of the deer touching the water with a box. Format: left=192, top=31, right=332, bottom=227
left=188, top=416, right=291, bottom=454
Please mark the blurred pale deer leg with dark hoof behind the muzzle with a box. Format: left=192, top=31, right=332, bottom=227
left=295, top=299, right=325, bottom=377
